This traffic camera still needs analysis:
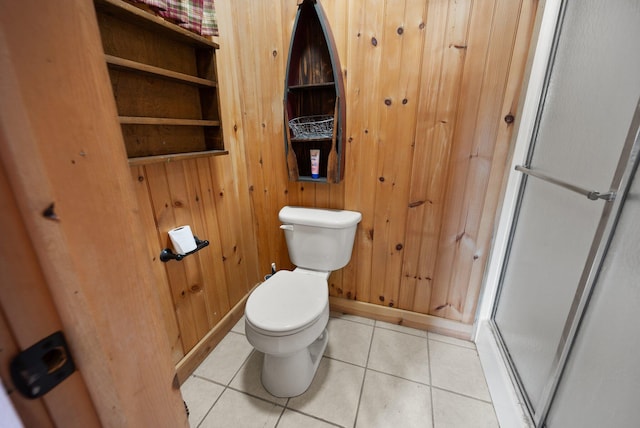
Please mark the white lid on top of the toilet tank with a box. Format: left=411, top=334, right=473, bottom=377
left=278, top=206, right=362, bottom=229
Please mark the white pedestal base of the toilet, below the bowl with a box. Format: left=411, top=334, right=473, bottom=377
left=262, top=328, right=329, bottom=397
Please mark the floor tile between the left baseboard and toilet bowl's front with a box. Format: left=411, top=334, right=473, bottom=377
left=194, top=332, right=253, bottom=385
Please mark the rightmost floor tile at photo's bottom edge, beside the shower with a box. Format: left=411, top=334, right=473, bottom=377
left=431, top=388, right=500, bottom=428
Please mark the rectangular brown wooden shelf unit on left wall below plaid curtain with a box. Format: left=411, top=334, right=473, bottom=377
left=94, top=0, right=228, bottom=165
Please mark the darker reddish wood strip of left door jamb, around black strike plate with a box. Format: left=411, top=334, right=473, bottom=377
left=0, top=162, right=99, bottom=427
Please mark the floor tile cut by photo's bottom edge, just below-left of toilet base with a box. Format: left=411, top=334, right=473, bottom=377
left=200, top=389, right=283, bottom=428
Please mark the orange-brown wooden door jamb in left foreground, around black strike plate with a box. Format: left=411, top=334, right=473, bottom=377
left=0, top=0, right=188, bottom=427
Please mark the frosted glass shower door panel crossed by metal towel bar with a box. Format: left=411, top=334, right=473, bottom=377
left=493, top=0, right=640, bottom=422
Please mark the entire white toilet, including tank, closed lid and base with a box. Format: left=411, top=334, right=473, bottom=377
left=245, top=207, right=362, bottom=397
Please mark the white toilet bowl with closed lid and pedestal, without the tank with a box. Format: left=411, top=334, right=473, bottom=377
left=245, top=269, right=329, bottom=397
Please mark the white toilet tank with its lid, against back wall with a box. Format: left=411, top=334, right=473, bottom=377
left=278, top=207, right=362, bottom=272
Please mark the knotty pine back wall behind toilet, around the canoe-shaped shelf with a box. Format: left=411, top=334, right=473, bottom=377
left=216, top=0, right=538, bottom=324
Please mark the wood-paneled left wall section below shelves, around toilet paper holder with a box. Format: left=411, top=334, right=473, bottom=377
left=131, top=156, right=258, bottom=363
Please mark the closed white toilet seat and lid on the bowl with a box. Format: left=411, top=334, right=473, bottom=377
left=245, top=270, right=329, bottom=336
